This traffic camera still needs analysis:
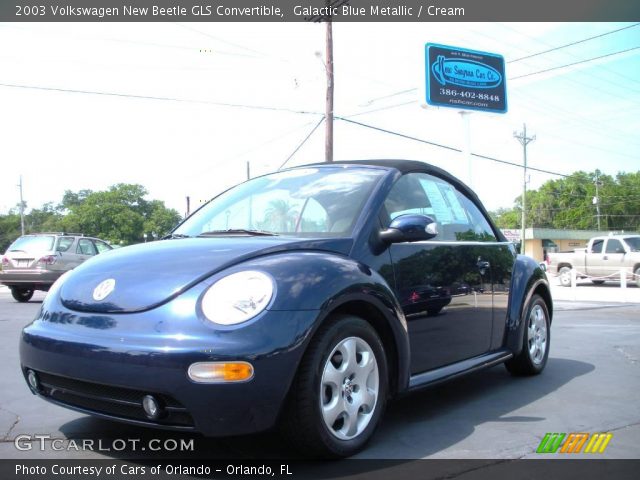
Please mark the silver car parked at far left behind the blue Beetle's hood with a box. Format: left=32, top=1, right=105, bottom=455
left=0, top=232, right=111, bottom=302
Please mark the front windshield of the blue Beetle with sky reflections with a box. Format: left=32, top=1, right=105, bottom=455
left=173, top=166, right=384, bottom=237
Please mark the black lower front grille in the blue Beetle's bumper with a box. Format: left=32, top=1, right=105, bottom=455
left=36, top=372, right=193, bottom=428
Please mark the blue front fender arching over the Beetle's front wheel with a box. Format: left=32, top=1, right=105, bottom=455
left=238, top=251, right=410, bottom=394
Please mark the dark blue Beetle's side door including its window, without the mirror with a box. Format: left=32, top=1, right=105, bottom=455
left=382, top=173, right=496, bottom=374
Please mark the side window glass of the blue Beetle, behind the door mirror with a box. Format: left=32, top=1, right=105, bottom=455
left=384, top=173, right=497, bottom=242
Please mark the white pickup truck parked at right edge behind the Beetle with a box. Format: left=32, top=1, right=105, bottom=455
left=549, top=235, right=640, bottom=287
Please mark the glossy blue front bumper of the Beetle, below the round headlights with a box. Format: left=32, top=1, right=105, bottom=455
left=20, top=284, right=318, bottom=436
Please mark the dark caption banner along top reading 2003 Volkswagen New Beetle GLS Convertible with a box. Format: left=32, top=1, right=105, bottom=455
left=0, top=0, right=640, bottom=22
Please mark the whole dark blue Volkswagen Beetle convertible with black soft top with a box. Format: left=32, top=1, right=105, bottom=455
left=20, top=160, right=552, bottom=457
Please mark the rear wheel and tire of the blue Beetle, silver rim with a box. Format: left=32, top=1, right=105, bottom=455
left=505, top=295, right=551, bottom=376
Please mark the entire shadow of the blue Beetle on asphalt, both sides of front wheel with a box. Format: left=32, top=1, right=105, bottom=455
left=60, top=358, right=595, bottom=460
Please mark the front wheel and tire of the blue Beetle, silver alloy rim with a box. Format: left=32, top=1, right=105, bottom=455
left=281, top=316, right=388, bottom=458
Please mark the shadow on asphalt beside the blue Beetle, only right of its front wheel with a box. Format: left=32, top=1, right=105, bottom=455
left=358, top=357, right=595, bottom=459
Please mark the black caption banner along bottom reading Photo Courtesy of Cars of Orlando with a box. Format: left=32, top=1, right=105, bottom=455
left=0, top=459, right=640, bottom=480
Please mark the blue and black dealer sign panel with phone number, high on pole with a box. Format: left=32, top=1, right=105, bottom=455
left=425, top=43, right=507, bottom=113
